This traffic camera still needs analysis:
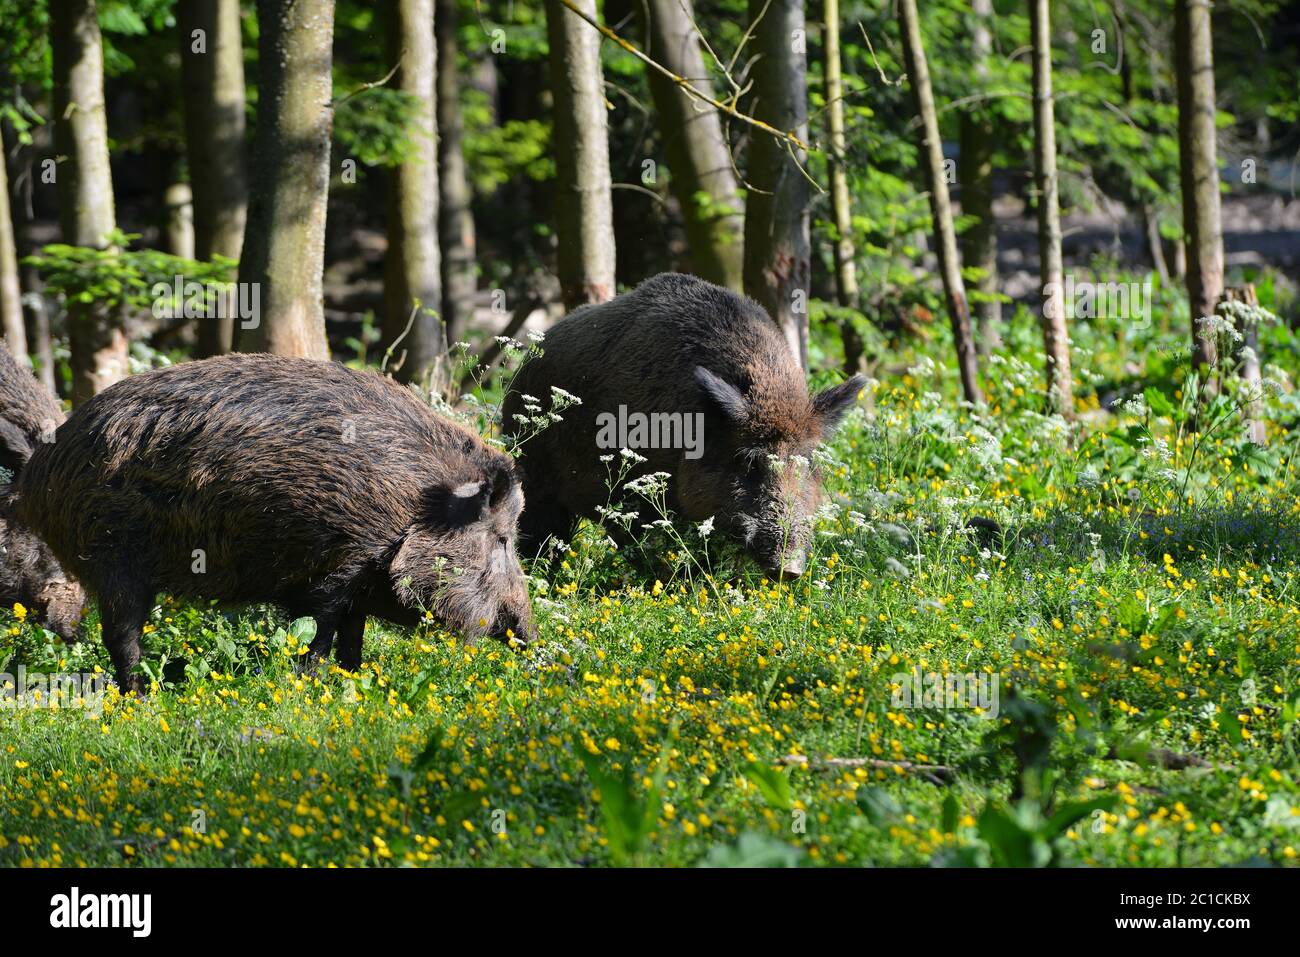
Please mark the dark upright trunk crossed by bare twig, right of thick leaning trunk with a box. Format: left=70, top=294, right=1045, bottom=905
left=745, top=0, right=813, bottom=369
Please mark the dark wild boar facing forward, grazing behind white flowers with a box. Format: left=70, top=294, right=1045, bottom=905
left=502, top=273, right=865, bottom=577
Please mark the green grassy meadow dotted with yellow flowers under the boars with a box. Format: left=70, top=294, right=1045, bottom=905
left=0, top=291, right=1300, bottom=866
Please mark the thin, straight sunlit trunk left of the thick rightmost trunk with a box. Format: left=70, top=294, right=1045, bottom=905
left=1030, top=0, right=1074, bottom=419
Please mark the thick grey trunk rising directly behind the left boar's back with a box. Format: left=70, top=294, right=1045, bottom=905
left=238, top=0, right=334, bottom=359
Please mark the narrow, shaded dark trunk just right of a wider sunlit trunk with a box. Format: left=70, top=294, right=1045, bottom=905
left=434, top=0, right=478, bottom=342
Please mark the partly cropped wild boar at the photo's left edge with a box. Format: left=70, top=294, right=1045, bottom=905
left=0, top=347, right=86, bottom=641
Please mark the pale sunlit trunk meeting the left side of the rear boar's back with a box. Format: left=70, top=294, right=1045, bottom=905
left=546, top=0, right=615, bottom=309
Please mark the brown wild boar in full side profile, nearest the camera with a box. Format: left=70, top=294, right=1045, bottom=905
left=18, top=355, right=533, bottom=690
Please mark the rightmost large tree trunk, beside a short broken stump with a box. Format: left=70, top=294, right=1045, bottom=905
left=1174, top=0, right=1223, bottom=390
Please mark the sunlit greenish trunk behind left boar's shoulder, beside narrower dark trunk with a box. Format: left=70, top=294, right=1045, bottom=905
left=384, top=0, right=447, bottom=391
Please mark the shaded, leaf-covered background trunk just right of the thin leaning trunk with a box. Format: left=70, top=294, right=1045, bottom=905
left=961, top=0, right=1002, bottom=355
